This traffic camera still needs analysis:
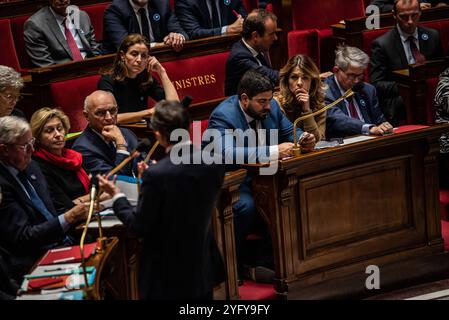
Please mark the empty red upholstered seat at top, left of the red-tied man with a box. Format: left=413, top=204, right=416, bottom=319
left=288, top=0, right=365, bottom=71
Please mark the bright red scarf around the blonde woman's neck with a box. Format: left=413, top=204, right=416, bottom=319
left=34, top=148, right=89, bottom=193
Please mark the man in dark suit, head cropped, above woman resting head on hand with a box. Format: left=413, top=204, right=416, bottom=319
left=103, top=0, right=189, bottom=53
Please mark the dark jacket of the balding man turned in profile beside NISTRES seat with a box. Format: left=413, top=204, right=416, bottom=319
left=225, top=40, right=279, bottom=96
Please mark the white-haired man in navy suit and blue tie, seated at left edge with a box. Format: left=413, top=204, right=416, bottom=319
left=0, top=116, right=88, bottom=280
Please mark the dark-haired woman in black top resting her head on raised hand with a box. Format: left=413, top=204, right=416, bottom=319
left=98, top=34, right=179, bottom=124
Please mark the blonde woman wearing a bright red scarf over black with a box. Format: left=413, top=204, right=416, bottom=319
left=30, top=108, right=89, bottom=211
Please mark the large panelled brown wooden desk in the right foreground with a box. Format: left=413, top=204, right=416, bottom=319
left=249, top=125, right=449, bottom=299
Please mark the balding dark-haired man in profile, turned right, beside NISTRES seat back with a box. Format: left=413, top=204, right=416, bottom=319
left=225, top=9, right=279, bottom=96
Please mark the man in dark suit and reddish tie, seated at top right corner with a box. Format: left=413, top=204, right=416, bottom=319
left=370, top=0, right=443, bottom=126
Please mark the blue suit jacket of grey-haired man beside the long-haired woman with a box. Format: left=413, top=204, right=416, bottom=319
left=325, top=75, right=385, bottom=138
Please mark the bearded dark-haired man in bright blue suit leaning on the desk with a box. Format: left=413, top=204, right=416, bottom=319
left=203, top=70, right=315, bottom=276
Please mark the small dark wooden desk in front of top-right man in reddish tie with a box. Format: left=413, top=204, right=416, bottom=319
left=393, top=59, right=449, bottom=125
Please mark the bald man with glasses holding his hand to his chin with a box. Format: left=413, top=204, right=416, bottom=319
left=73, top=90, right=138, bottom=176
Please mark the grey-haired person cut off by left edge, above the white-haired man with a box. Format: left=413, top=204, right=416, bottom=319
left=0, top=66, right=25, bottom=118
